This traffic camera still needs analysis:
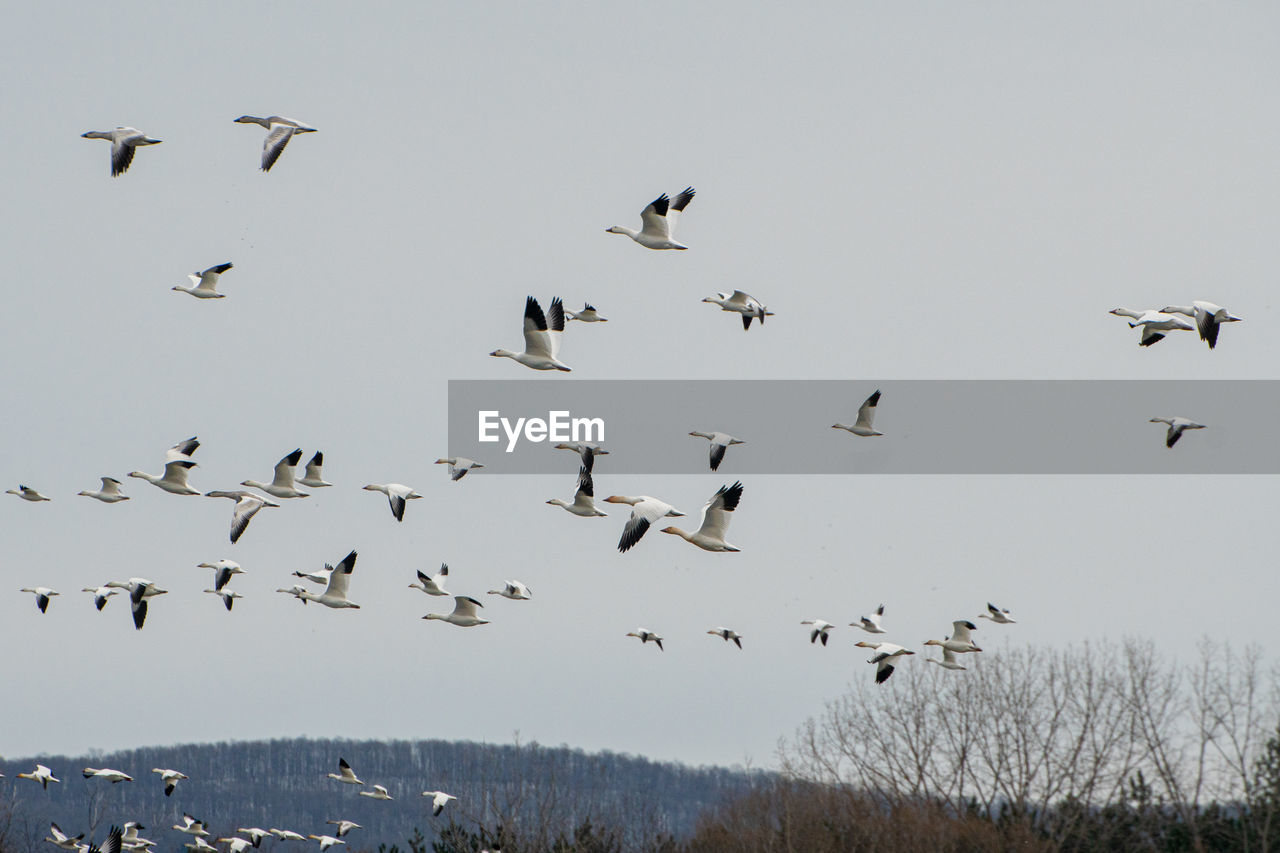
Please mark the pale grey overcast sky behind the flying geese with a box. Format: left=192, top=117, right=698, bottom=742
left=0, top=1, right=1280, bottom=766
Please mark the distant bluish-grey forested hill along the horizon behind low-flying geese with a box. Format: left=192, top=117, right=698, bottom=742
left=0, top=739, right=764, bottom=853
